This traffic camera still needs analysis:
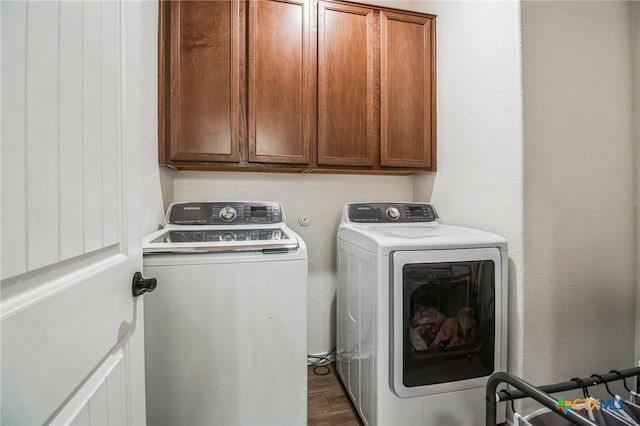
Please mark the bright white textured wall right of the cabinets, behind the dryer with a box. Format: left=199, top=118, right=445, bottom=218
left=414, top=1, right=523, bottom=372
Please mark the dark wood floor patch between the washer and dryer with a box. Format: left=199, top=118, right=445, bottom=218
left=307, top=364, right=362, bottom=426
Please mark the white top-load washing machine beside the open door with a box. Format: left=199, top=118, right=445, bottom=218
left=143, top=202, right=307, bottom=426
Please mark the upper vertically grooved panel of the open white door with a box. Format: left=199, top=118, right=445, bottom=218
left=1, top=2, right=123, bottom=280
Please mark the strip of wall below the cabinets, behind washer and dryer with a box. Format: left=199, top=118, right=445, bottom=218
left=174, top=172, right=412, bottom=354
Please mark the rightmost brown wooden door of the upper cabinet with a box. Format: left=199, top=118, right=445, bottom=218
left=380, top=11, right=436, bottom=169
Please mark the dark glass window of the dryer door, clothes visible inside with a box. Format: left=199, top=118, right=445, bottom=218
left=402, top=260, right=495, bottom=387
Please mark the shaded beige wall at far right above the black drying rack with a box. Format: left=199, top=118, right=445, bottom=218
left=520, top=2, right=636, bottom=383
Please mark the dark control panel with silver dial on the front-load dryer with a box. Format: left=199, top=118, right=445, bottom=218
left=347, top=203, right=438, bottom=223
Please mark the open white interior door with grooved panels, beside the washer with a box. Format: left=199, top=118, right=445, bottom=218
left=0, top=0, right=145, bottom=425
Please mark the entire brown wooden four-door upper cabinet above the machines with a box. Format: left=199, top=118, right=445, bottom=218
left=158, top=0, right=436, bottom=174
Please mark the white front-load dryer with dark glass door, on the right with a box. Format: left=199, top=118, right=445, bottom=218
left=337, top=202, right=508, bottom=426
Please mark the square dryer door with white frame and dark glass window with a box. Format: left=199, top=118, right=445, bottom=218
left=391, top=248, right=503, bottom=398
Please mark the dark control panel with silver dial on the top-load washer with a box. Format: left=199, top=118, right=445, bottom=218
left=167, top=201, right=284, bottom=225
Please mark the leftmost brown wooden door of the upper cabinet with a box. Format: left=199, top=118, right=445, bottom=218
left=169, top=0, right=243, bottom=161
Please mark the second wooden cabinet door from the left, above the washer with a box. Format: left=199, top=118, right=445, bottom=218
left=247, top=0, right=316, bottom=164
